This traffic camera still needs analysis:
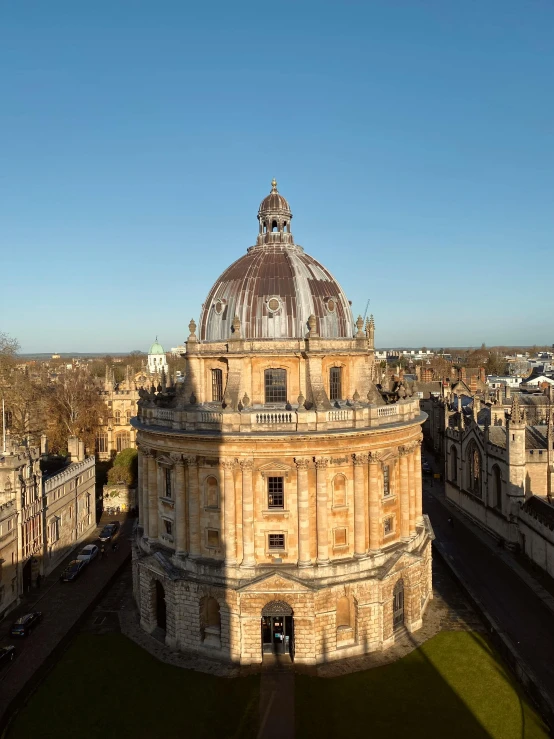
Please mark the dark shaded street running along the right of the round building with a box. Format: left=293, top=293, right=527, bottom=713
left=423, top=459, right=554, bottom=699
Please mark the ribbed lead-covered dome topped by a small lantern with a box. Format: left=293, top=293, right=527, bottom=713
left=200, top=180, right=353, bottom=341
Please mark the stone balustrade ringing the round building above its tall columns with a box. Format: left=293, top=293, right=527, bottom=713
left=133, top=398, right=421, bottom=434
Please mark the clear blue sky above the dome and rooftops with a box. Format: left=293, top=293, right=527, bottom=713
left=0, top=0, right=554, bottom=352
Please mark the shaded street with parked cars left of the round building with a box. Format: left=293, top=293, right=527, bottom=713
left=0, top=517, right=135, bottom=730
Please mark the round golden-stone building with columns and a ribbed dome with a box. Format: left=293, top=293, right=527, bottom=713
left=133, top=181, right=433, bottom=664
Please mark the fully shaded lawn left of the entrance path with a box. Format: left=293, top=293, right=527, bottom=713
left=8, top=634, right=260, bottom=739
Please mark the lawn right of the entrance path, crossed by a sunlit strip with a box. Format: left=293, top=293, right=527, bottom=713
left=296, top=631, right=548, bottom=739
